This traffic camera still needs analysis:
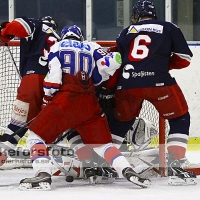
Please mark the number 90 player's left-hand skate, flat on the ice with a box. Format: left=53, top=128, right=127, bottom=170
left=19, top=172, right=52, bottom=190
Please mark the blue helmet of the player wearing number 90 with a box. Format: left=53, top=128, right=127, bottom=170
left=61, top=25, right=84, bottom=41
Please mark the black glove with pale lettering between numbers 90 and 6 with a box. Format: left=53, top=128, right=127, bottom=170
left=98, top=87, right=115, bottom=113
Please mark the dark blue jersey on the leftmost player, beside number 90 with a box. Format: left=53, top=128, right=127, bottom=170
left=15, top=17, right=60, bottom=77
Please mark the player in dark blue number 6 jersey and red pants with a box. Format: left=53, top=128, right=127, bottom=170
left=104, top=0, right=196, bottom=185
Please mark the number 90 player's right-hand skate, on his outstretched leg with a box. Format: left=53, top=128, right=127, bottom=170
left=122, top=167, right=151, bottom=188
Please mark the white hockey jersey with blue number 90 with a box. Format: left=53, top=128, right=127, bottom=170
left=44, top=39, right=121, bottom=97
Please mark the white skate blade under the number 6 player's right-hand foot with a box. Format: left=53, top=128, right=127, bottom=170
left=168, top=176, right=197, bottom=186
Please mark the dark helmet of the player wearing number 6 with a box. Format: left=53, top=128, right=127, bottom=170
left=131, top=0, right=157, bottom=23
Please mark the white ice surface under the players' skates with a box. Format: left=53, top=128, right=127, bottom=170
left=0, top=152, right=200, bottom=200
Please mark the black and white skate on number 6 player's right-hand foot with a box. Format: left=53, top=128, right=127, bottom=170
left=168, top=160, right=197, bottom=186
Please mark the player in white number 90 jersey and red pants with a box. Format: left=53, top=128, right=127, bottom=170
left=20, top=25, right=150, bottom=189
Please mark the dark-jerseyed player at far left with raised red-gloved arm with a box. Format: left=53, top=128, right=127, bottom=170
left=0, top=16, right=60, bottom=166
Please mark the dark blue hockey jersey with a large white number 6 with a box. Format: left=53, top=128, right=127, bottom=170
left=116, top=20, right=193, bottom=89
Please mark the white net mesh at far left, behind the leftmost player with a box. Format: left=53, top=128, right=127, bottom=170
left=0, top=41, right=20, bottom=127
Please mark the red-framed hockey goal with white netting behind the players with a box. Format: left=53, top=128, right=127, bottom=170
left=0, top=41, right=200, bottom=176
